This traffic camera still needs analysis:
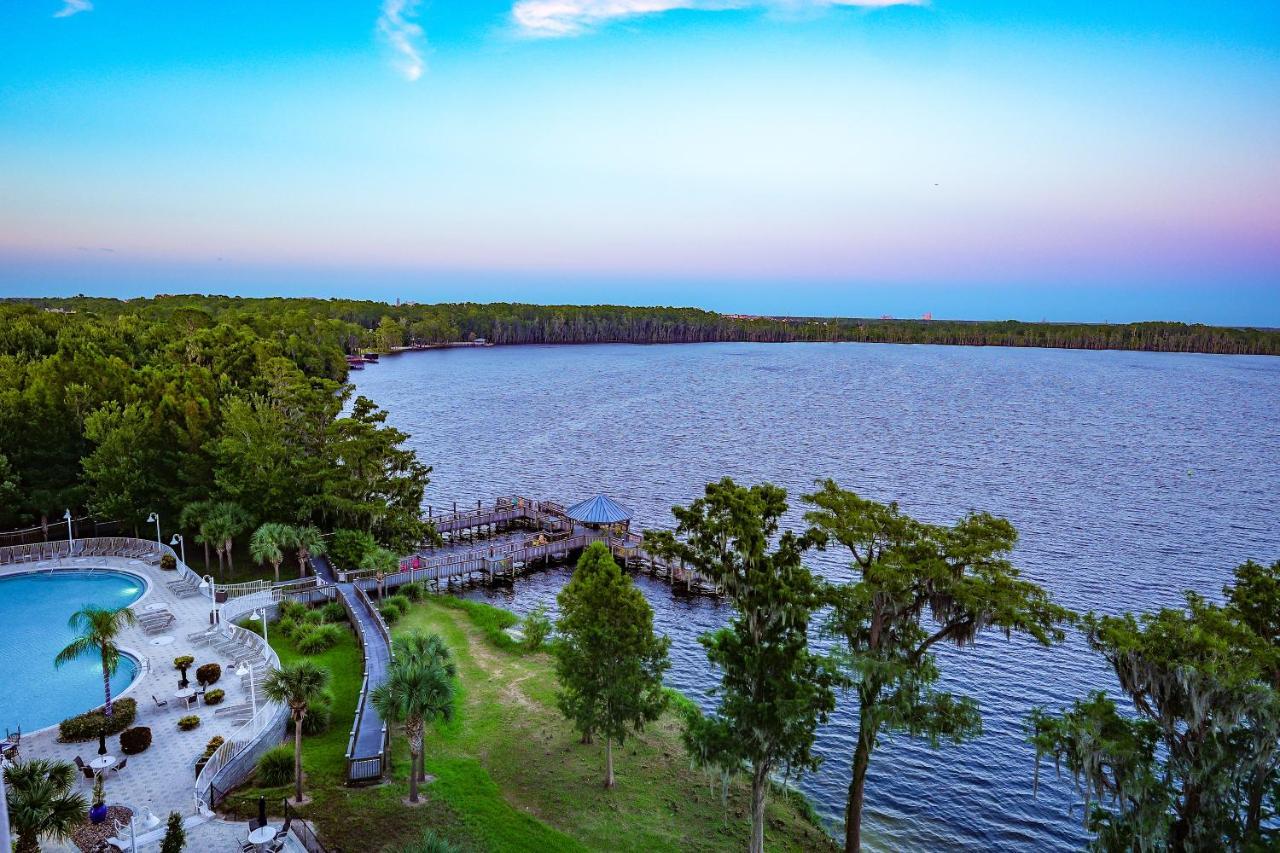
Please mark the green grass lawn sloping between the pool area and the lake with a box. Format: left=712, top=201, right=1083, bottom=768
left=225, top=591, right=836, bottom=853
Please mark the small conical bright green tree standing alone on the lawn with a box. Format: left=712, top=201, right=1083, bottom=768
left=554, top=542, right=671, bottom=788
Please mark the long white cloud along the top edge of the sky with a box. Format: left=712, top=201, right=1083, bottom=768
left=511, top=0, right=927, bottom=38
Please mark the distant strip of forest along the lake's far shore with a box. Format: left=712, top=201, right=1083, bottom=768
left=10, top=296, right=1280, bottom=355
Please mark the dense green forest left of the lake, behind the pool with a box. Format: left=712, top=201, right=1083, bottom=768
left=0, top=300, right=430, bottom=545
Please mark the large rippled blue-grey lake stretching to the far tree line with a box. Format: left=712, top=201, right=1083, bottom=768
left=352, top=343, right=1280, bottom=850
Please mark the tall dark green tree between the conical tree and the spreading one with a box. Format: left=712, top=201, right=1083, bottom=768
left=646, top=478, right=838, bottom=853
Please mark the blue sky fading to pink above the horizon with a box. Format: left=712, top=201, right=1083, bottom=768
left=0, top=0, right=1280, bottom=327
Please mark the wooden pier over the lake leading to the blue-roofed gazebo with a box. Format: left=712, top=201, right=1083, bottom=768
left=342, top=497, right=719, bottom=594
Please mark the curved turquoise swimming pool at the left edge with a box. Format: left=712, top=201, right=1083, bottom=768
left=0, top=569, right=146, bottom=735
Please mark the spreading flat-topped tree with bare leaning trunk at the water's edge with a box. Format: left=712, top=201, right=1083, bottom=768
left=805, top=480, right=1069, bottom=853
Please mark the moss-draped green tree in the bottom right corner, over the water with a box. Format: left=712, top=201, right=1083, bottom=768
left=1030, top=562, right=1280, bottom=850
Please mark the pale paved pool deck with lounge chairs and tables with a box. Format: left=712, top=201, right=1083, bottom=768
left=0, top=557, right=294, bottom=850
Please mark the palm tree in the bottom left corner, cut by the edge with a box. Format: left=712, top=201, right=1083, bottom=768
left=4, top=758, right=88, bottom=853
